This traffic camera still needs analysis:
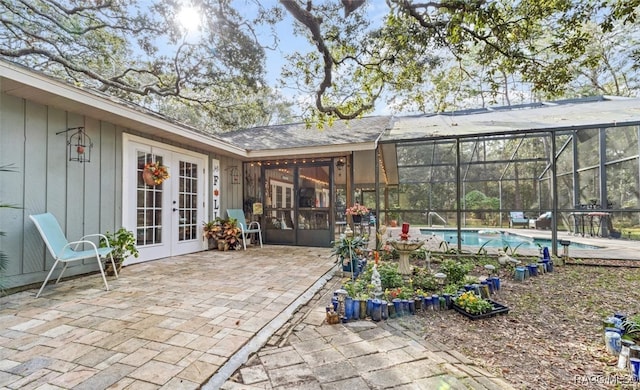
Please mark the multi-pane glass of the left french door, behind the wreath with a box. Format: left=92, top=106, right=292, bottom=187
left=136, top=151, right=164, bottom=245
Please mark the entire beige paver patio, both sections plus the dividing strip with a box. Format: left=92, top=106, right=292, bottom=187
left=0, top=246, right=512, bottom=390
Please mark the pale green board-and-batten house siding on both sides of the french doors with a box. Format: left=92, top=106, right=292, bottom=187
left=0, top=88, right=236, bottom=288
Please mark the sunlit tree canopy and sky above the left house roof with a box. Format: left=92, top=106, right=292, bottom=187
left=0, top=0, right=290, bottom=129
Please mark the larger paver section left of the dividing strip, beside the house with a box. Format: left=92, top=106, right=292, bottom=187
left=0, top=245, right=334, bottom=389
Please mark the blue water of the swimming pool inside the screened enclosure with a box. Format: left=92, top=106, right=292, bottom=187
left=420, top=229, right=601, bottom=249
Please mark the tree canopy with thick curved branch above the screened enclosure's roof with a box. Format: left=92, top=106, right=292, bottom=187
left=281, top=0, right=640, bottom=119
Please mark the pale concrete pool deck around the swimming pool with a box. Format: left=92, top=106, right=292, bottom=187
left=387, top=226, right=640, bottom=260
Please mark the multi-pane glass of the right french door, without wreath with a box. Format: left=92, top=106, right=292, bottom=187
left=178, top=161, right=198, bottom=241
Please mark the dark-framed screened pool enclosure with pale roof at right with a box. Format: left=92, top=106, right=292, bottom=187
left=354, top=98, right=640, bottom=253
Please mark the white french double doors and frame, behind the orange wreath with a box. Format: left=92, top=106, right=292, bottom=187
left=122, top=135, right=207, bottom=264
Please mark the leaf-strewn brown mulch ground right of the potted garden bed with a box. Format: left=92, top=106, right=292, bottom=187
left=402, top=260, right=640, bottom=389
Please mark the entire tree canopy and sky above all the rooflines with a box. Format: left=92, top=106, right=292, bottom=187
left=0, top=0, right=640, bottom=131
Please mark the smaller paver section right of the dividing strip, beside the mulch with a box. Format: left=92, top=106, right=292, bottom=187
left=222, top=268, right=513, bottom=390
